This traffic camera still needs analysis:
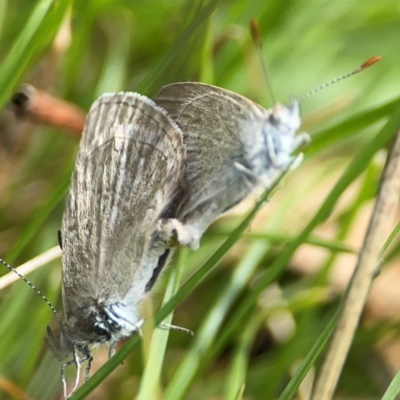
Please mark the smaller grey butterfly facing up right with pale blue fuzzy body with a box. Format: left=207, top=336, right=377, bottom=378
left=155, top=83, right=308, bottom=245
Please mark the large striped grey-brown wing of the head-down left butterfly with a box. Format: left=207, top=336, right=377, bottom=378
left=62, top=93, right=185, bottom=318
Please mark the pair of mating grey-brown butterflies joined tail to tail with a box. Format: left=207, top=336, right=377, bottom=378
left=44, top=56, right=380, bottom=397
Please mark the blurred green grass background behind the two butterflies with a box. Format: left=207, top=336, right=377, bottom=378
left=0, top=0, right=400, bottom=400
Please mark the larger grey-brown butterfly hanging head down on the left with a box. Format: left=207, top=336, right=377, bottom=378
left=48, top=93, right=197, bottom=397
